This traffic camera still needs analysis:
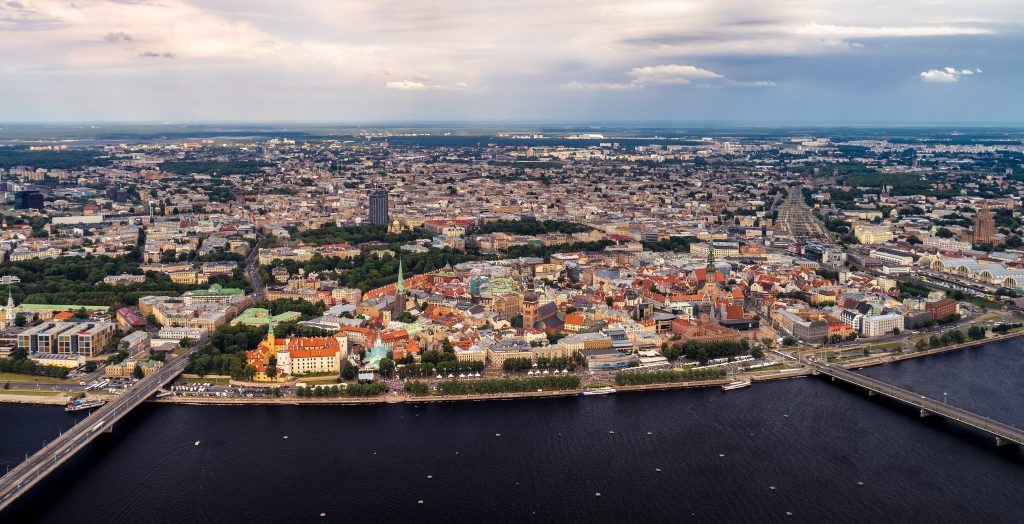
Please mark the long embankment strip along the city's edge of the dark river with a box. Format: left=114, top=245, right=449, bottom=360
left=6, top=332, right=1024, bottom=405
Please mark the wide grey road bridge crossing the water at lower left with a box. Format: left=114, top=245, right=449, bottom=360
left=0, top=344, right=193, bottom=511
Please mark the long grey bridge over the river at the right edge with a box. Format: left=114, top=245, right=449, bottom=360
left=806, top=361, right=1024, bottom=446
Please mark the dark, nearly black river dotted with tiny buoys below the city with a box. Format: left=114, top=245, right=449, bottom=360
left=0, top=340, right=1024, bottom=524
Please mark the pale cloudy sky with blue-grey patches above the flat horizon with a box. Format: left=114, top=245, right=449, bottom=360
left=0, top=0, right=1024, bottom=125
